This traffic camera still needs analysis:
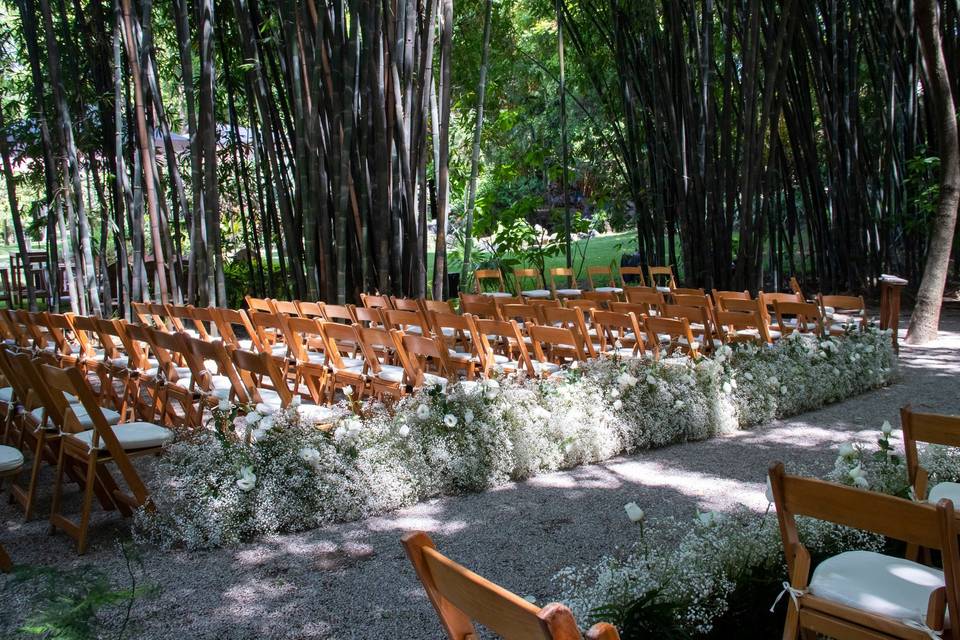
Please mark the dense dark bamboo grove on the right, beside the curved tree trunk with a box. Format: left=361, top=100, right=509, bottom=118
left=563, top=0, right=960, bottom=290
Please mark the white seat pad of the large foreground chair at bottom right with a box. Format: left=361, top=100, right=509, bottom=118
left=809, top=551, right=944, bottom=621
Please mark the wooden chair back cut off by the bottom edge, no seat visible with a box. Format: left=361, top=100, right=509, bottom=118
left=402, top=531, right=620, bottom=640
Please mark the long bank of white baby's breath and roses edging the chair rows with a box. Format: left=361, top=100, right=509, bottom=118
left=137, top=328, right=895, bottom=548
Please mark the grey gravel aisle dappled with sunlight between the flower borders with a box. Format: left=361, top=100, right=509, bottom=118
left=0, top=312, right=960, bottom=639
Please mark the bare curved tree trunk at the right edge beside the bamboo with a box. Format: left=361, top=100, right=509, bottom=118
left=907, top=0, right=960, bottom=344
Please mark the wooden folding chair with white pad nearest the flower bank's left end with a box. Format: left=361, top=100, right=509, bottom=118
left=41, top=365, right=173, bottom=554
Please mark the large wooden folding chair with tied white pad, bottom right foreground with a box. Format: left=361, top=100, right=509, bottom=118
left=770, top=462, right=960, bottom=640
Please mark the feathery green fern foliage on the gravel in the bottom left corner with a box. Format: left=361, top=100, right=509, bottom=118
left=6, top=544, right=156, bottom=640
